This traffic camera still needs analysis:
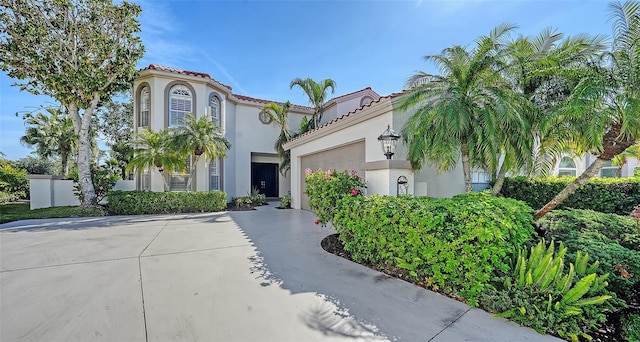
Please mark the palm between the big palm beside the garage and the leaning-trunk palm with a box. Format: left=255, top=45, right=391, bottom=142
left=490, top=28, right=605, bottom=195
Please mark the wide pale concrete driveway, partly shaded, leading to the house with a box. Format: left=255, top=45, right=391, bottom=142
left=0, top=206, right=555, bottom=342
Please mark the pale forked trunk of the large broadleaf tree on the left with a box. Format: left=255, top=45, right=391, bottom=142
left=67, top=97, right=100, bottom=207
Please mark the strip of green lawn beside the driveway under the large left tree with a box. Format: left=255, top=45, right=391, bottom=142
left=0, top=202, right=105, bottom=223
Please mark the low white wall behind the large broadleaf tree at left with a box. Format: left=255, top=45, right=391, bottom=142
left=27, top=175, right=136, bottom=210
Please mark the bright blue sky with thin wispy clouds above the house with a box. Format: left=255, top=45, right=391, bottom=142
left=0, top=0, right=611, bottom=160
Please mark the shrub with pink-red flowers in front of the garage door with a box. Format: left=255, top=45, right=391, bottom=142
left=305, top=169, right=366, bottom=226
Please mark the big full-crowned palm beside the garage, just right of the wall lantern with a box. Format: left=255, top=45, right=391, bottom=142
left=400, top=24, right=526, bottom=192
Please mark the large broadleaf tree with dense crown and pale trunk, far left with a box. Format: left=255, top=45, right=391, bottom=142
left=0, top=0, right=144, bottom=205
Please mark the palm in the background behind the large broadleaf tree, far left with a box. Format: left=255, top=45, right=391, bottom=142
left=20, top=108, right=78, bottom=177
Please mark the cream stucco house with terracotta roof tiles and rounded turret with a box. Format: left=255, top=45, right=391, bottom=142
left=133, top=64, right=640, bottom=209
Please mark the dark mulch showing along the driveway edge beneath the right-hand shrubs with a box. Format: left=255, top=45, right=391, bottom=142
left=320, top=234, right=640, bottom=342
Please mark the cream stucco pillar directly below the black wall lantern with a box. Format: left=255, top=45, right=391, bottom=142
left=364, top=160, right=414, bottom=196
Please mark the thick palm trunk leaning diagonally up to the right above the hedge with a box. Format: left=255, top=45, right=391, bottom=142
left=533, top=124, right=636, bottom=220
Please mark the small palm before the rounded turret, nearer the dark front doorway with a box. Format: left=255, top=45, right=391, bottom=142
left=171, top=114, right=231, bottom=191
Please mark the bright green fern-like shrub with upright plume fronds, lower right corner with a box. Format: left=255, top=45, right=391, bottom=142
left=480, top=240, right=622, bottom=341
